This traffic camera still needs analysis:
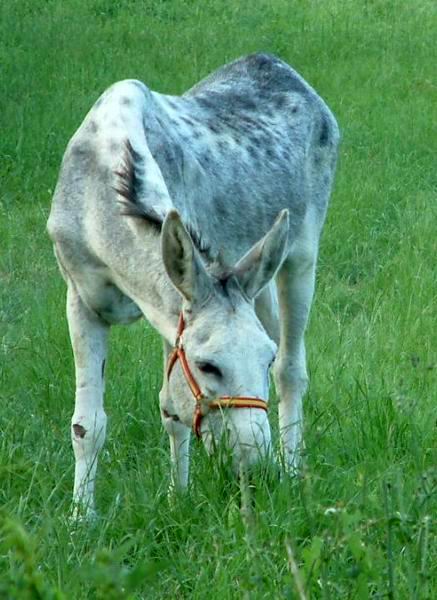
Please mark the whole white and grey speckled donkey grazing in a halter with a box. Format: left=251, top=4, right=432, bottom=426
left=48, top=54, right=339, bottom=513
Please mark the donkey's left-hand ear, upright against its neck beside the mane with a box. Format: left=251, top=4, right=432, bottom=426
left=161, top=210, right=210, bottom=303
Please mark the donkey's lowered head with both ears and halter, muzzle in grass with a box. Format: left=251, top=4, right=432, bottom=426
left=161, top=210, right=288, bottom=468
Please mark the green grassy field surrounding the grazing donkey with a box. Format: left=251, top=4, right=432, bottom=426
left=0, top=0, right=437, bottom=600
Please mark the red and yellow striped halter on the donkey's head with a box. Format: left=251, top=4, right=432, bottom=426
left=167, top=313, right=268, bottom=438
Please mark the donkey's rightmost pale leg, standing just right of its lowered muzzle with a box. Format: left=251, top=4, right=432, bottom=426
left=274, top=255, right=315, bottom=472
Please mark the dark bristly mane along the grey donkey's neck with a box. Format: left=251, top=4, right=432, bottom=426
left=114, top=140, right=213, bottom=265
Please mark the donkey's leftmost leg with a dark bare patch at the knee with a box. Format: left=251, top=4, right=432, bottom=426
left=67, top=283, right=109, bottom=516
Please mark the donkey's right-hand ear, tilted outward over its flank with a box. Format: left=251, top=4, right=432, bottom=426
left=234, top=210, right=288, bottom=298
